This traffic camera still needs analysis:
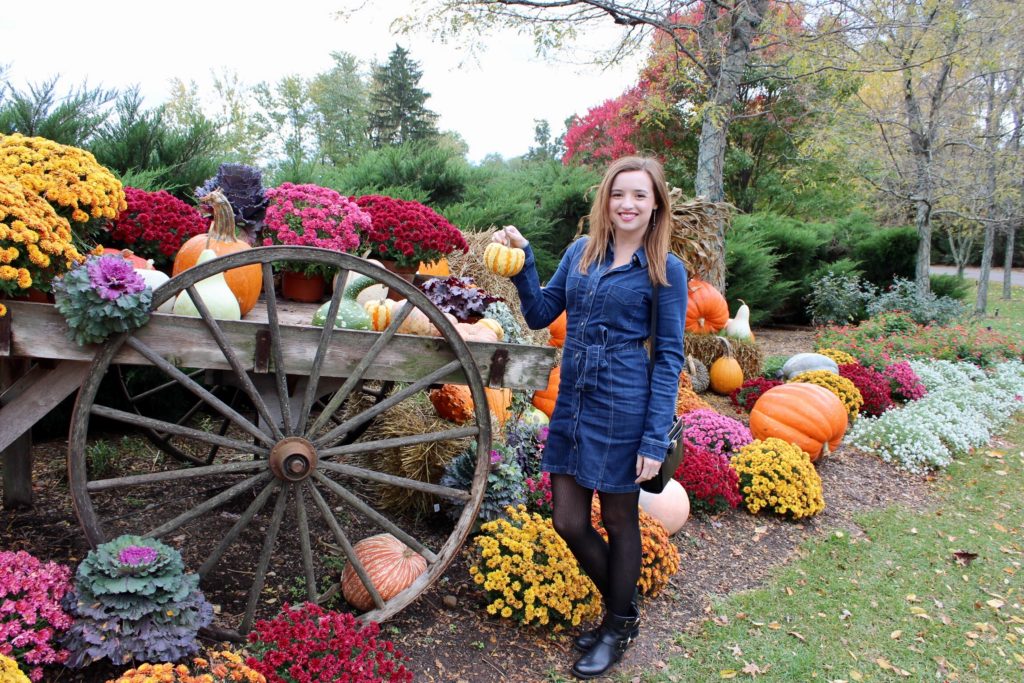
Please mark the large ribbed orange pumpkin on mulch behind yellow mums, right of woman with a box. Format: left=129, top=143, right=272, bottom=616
left=751, top=382, right=848, bottom=463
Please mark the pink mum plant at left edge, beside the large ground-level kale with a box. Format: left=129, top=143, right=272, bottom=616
left=0, top=551, right=72, bottom=681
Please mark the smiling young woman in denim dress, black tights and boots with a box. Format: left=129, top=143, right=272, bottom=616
left=494, top=157, right=686, bottom=679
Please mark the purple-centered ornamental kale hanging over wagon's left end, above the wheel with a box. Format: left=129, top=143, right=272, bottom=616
left=53, top=254, right=153, bottom=344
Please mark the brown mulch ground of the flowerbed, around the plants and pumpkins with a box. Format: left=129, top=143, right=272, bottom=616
left=0, top=330, right=930, bottom=683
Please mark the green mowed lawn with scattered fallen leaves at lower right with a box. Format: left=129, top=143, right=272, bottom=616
left=646, top=413, right=1024, bottom=683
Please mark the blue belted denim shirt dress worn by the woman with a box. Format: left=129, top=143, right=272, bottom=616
left=512, top=238, right=686, bottom=494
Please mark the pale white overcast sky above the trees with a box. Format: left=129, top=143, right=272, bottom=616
left=0, top=0, right=639, bottom=161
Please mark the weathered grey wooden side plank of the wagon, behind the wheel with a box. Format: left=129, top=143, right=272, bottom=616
left=7, top=301, right=555, bottom=390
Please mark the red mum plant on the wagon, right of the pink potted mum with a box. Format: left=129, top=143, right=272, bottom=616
left=355, top=195, right=469, bottom=266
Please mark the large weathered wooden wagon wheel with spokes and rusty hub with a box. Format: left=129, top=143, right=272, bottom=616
left=69, top=247, right=490, bottom=635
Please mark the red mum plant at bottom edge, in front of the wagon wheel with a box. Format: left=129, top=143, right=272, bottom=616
left=246, top=602, right=413, bottom=683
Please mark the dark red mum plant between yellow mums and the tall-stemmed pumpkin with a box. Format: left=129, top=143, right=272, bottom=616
left=106, top=187, right=210, bottom=270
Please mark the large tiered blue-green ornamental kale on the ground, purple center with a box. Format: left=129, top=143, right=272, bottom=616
left=63, top=536, right=213, bottom=668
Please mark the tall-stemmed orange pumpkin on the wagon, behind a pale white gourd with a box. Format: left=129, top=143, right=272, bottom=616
left=171, top=189, right=263, bottom=315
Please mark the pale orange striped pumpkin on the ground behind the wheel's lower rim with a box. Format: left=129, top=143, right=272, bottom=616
left=341, top=533, right=427, bottom=611
